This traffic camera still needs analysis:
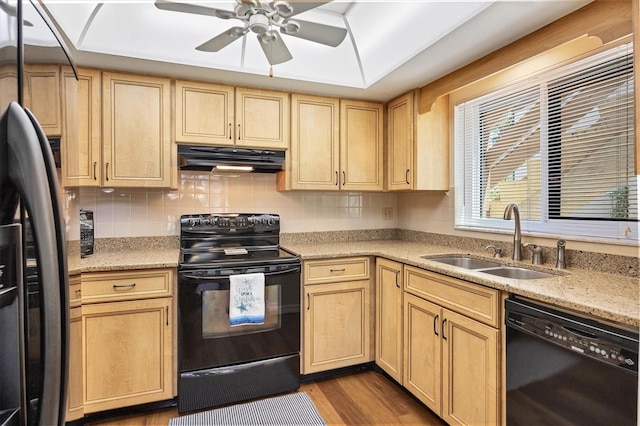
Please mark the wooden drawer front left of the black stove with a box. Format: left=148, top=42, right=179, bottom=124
left=82, top=269, right=173, bottom=303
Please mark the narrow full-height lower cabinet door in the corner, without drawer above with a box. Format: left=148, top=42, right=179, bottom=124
left=376, top=258, right=403, bottom=383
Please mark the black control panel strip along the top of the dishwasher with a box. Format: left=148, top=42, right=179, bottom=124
left=507, top=312, right=638, bottom=372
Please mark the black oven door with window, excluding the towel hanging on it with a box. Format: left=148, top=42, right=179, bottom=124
left=178, top=262, right=300, bottom=373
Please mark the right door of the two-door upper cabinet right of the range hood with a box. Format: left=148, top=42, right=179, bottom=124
left=340, top=100, right=384, bottom=191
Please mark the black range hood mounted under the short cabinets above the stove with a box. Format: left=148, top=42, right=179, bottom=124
left=178, top=145, right=284, bottom=173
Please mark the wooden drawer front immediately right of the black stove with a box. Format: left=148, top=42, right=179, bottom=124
left=304, top=257, right=370, bottom=285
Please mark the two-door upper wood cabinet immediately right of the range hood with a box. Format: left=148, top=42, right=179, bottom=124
left=278, top=94, right=383, bottom=191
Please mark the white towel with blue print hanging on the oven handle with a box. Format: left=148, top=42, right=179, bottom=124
left=229, top=273, right=265, bottom=326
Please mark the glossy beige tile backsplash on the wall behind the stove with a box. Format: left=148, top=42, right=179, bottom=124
left=78, top=172, right=398, bottom=238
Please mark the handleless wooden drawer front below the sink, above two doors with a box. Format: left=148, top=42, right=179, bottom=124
left=404, top=266, right=500, bottom=328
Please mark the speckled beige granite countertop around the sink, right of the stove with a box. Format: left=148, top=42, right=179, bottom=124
left=285, top=240, right=640, bottom=327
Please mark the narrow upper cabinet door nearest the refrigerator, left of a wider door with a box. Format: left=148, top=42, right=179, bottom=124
left=62, top=69, right=102, bottom=186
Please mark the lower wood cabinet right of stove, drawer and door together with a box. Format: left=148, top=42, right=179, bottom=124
left=302, top=257, right=373, bottom=374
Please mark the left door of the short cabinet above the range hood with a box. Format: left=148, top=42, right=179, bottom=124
left=175, top=81, right=234, bottom=145
